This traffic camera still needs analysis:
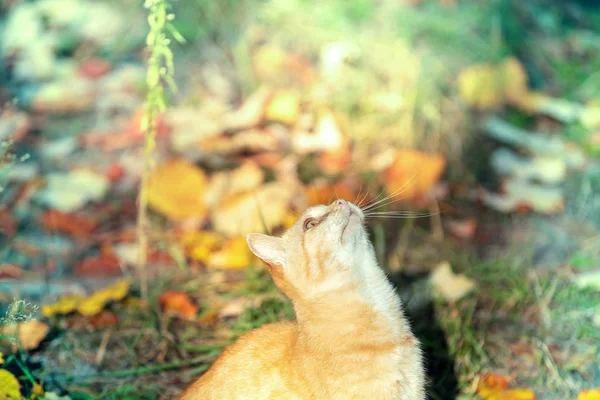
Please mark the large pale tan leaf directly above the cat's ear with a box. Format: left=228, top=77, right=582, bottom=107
left=212, top=182, right=299, bottom=236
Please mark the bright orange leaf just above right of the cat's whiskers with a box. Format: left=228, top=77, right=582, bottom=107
left=382, top=149, right=446, bottom=202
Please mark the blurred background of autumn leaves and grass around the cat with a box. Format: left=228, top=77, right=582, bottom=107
left=0, top=0, right=600, bottom=399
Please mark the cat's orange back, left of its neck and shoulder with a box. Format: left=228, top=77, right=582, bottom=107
left=180, top=321, right=296, bottom=400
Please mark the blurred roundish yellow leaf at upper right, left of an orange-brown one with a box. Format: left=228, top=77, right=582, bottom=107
left=458, top=64, right=503, bottom=110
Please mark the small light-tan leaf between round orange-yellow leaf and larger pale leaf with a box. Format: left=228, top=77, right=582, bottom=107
left=204, top=162, right=265, bottom=207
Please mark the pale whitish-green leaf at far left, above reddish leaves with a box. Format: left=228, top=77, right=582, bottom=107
left=38, top=169, right=109, bottom=213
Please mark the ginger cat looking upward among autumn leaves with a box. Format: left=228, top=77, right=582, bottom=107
left=180, top=200, right=425, bottom=400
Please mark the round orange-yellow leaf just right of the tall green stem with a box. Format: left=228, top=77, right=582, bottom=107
left=148, top=160, right=207, bottom=220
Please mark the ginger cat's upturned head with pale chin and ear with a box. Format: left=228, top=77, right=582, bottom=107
left=246, top=200, right=375, bottom=299
